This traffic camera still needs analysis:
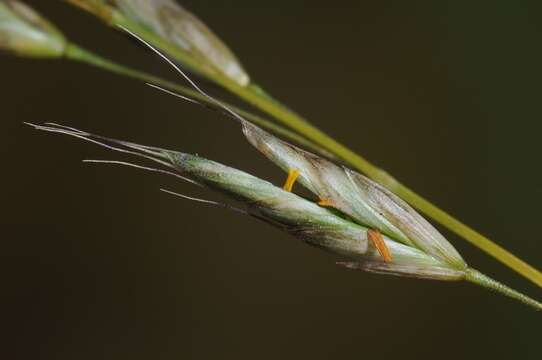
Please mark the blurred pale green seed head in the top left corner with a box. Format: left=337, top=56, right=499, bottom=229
left=0, top=0, right=66, bottom=58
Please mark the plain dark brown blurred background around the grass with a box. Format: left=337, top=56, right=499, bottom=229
left=0, top=0, right=542, bottom=360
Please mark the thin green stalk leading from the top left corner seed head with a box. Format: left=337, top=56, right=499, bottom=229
left=64, top=43, right=335, bottom=159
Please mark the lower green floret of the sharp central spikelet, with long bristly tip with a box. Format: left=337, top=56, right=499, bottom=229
left=26, top=125, right=465, bottom=280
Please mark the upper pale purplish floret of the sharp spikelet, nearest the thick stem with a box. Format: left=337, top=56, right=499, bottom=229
left=243, top=121, right=467, bottom=269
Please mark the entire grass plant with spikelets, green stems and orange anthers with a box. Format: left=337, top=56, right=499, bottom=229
left=0, top=0, right=542, bottom=310
